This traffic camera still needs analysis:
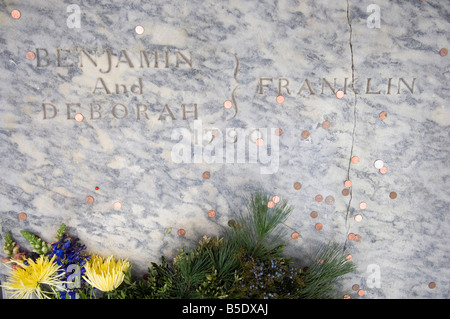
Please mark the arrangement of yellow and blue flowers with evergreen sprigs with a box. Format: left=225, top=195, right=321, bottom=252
left=2, top=192, right=355, bottom=299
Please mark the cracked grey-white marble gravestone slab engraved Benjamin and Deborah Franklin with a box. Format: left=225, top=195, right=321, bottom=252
left=0, top=0, right=450, bottom=298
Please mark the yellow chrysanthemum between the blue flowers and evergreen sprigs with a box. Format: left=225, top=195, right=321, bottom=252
left=83, top=255, right=131, bottom=292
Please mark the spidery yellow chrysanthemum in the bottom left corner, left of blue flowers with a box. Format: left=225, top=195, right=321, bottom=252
left=2, top=256, right=65, bottom=299
